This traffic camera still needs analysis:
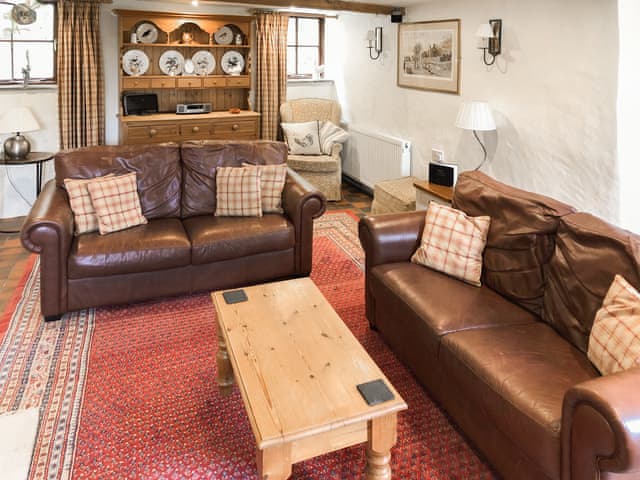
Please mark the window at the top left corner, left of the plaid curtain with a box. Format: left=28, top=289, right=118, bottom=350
left=0, top=2, right=56, bottom=85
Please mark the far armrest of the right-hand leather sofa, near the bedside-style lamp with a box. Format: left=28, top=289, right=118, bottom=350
left=358, top=211, right=425, bottom=271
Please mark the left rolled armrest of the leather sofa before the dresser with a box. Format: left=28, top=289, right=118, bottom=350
left=20, top=180, right=73, bottom=317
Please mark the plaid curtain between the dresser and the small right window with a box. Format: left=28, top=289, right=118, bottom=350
left=256, top=12, right=289, bottom=140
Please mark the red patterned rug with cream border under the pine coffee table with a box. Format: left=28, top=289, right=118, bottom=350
left=0, top=212, right=493, bottom=480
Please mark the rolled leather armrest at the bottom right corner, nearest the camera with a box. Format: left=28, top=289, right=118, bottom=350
left=562, top=368, right=640, bottom=480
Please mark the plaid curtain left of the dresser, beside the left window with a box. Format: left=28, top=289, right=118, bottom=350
left=57, top=0, right=104, bottom=149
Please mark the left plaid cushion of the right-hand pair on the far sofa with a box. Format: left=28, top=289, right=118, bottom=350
left=216, top=167, right=262, bottom=217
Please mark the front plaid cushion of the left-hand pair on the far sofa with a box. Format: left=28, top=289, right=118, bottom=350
left=87, top=172, right=147, bottom=235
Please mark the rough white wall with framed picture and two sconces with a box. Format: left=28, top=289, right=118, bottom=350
left=330, top=0, right=624, bottom=222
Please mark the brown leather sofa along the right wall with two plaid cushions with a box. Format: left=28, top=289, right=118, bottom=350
left=359, top=172, right=640, bottom=480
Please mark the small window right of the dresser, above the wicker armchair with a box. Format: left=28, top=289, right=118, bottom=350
left=287, top=17, right=324, bottom=78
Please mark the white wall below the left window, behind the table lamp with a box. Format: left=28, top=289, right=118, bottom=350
left=0, top=88, right=59, bottom=218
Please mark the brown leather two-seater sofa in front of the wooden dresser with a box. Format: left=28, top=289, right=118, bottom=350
left=21, top=141, right=326, bottom=320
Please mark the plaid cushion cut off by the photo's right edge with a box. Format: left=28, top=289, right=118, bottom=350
left=587, top=275, right=640, bottom=375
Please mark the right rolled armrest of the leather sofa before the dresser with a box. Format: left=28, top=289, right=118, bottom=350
left=282, top=168, right=327, bottom=275
